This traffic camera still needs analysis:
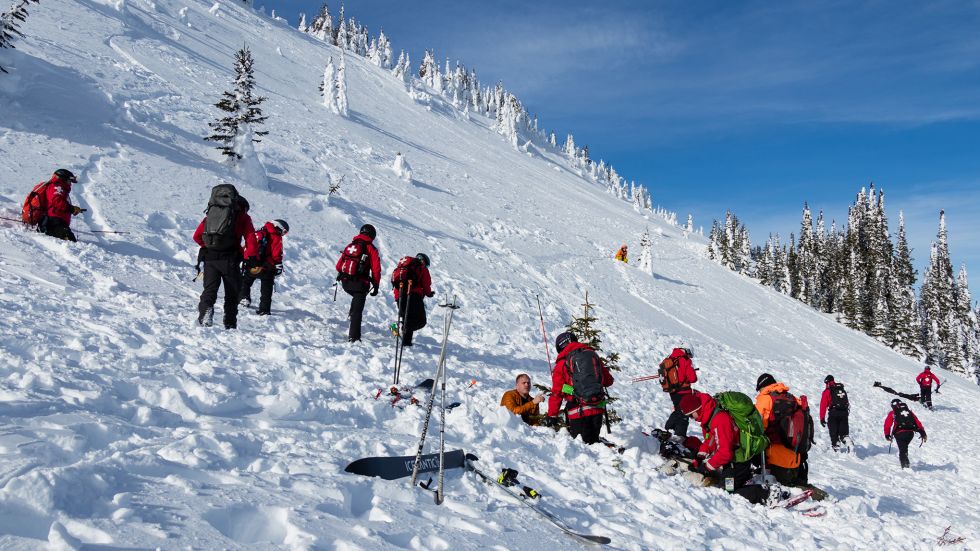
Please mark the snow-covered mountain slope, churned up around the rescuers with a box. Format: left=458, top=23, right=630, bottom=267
left=0, top=0, right=980, bottom=549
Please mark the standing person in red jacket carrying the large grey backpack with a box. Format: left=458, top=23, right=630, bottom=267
left=194, top=184, right=258, bottom=329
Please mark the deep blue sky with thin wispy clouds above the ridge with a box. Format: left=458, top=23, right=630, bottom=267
left=255, top=0, right=980, bottom=296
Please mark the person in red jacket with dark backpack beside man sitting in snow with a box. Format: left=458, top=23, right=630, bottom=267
left=546, top=331, right=613, bottom=444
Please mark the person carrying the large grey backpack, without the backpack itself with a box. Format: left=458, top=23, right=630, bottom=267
left=194, top=197, right=258, bottom=329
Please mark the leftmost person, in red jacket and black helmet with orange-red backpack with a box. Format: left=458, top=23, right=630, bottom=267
left=21, top=168, right=85, bottom=241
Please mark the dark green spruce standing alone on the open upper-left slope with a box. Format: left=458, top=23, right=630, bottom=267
left=204, top=46, right=268, bottom=162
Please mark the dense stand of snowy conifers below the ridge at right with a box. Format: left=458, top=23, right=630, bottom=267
left=708, top=184, right=980, bottom=379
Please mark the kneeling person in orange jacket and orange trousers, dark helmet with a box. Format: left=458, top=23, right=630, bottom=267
left=755, top=373, right=809, bottom=486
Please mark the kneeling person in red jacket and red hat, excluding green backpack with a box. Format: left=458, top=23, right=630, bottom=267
left=679, top=391, right=769, bottom=503
